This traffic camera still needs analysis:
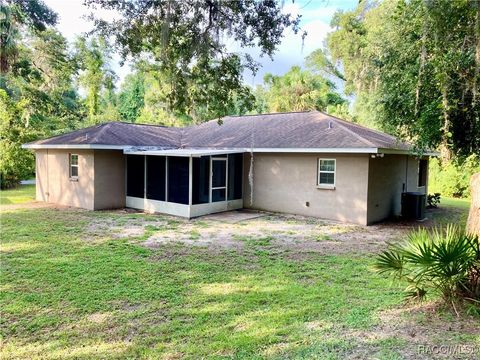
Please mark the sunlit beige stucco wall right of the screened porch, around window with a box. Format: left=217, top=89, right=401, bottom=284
left=244, top=153, right=369, bottom=224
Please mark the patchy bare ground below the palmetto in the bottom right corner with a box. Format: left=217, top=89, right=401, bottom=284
left=342, top=303, right=480, bottom=360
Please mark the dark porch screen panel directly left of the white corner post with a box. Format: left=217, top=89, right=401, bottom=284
left=167, top=156, right=190, bottom=205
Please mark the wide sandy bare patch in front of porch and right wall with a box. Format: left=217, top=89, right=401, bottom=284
left=143, top=214, right=407, bottom=258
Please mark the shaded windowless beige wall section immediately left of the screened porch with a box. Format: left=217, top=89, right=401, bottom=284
left=94, top=150, right=125, bottom=210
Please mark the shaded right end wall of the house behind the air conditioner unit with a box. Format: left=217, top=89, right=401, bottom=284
left=367, top=155, right=428, bottom=224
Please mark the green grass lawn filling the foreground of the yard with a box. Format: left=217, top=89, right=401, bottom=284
left=0, top=187, right=480, bottom=359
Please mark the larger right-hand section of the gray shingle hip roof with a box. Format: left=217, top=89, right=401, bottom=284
left=182, top=111, right=408, bottom=149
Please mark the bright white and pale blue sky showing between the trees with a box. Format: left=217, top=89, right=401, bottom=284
left=44, top=0, right=358, bottom=86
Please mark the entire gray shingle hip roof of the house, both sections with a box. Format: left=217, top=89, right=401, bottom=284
left=25, top=111, right=410, bottom=150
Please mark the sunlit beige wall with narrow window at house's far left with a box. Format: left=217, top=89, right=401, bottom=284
left=36, top=149, right=95, bottom=210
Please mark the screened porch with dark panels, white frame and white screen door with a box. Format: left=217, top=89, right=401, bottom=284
left=126, top=150, right=243, bottom=218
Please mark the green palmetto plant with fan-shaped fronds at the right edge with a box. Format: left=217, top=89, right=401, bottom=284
left=374, top=225, right=480, bottom=305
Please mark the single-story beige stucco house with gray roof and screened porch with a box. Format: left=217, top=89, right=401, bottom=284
left=24, top=111, right=434, bottom=225
